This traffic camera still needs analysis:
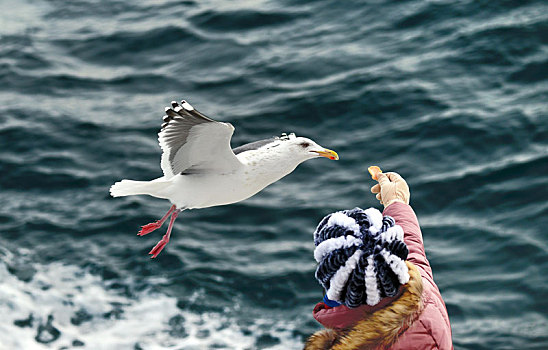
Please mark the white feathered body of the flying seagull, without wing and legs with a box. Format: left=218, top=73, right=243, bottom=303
left=110, top=137, right=323, bottom=209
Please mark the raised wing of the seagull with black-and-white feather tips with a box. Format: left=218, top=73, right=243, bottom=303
left=158, top=100, right=242, bottom=178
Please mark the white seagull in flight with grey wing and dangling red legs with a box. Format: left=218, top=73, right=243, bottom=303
left=110, top=100, right=339, bottom=258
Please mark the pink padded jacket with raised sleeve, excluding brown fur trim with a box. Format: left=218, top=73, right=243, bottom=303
left=305, top=202, right=453, bottom=350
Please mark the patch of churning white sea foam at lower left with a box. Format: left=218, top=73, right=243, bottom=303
left=0, top=261, right=302, bottom=350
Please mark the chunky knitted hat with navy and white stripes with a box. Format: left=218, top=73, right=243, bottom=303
left=314, top=208, right=409, bottom=308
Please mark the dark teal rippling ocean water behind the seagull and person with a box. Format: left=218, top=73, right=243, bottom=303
left=0, top=0, right=548, bottom=350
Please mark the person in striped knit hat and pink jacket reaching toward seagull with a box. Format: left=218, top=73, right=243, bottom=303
left=304, top=172, right=453, bottom=350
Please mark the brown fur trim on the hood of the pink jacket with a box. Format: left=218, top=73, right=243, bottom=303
left=304, top=261, right=424, bottom=350
